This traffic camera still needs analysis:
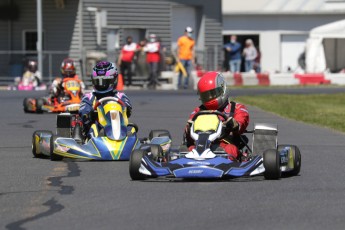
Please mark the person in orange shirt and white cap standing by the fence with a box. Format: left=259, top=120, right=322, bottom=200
left=177, top=26, right=195, bottom=89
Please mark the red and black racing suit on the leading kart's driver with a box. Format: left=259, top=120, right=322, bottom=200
left=184, top=101, right=249, bottom=159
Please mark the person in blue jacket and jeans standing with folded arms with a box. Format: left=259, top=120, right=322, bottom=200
left=224, top=35, right=242, bottom=73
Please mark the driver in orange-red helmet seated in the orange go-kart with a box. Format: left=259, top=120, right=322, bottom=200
left=50, top=58, right=85, bottom=103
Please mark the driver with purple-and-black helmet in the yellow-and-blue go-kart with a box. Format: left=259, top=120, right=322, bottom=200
left=79, top=61, right=132, bottom=138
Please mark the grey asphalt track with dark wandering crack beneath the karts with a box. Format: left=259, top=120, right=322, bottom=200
left=0, top=88, right=345, bottom=230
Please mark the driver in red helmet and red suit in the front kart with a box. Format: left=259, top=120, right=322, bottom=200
left=184, top=72, right=249, bottom=160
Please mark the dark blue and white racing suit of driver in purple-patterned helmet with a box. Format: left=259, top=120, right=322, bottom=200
left=79, top=90, right=132, bottom=138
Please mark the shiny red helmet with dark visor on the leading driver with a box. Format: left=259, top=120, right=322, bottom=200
left=198, top=71, right=229, bottom=110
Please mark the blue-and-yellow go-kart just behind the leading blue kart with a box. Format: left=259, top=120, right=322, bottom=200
left=32, top=97, right=140, bottom=161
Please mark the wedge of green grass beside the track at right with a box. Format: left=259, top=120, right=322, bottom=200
left=236, top=93, right=345, bottom=132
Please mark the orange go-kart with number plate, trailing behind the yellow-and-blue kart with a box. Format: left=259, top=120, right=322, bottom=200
left=23, top=78, right=82, bottom=113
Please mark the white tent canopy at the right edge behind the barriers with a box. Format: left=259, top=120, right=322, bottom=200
left=306, top=20, right=345, bottom=73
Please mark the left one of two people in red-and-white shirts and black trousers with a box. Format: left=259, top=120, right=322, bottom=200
left=117, top=36, right=138, bottom=86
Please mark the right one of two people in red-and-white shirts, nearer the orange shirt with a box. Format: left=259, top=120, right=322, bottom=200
left=144, top=34, right=161, bottom=89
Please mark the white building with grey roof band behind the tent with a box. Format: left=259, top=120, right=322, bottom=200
left=222, top=0, right=345, bottom=72
